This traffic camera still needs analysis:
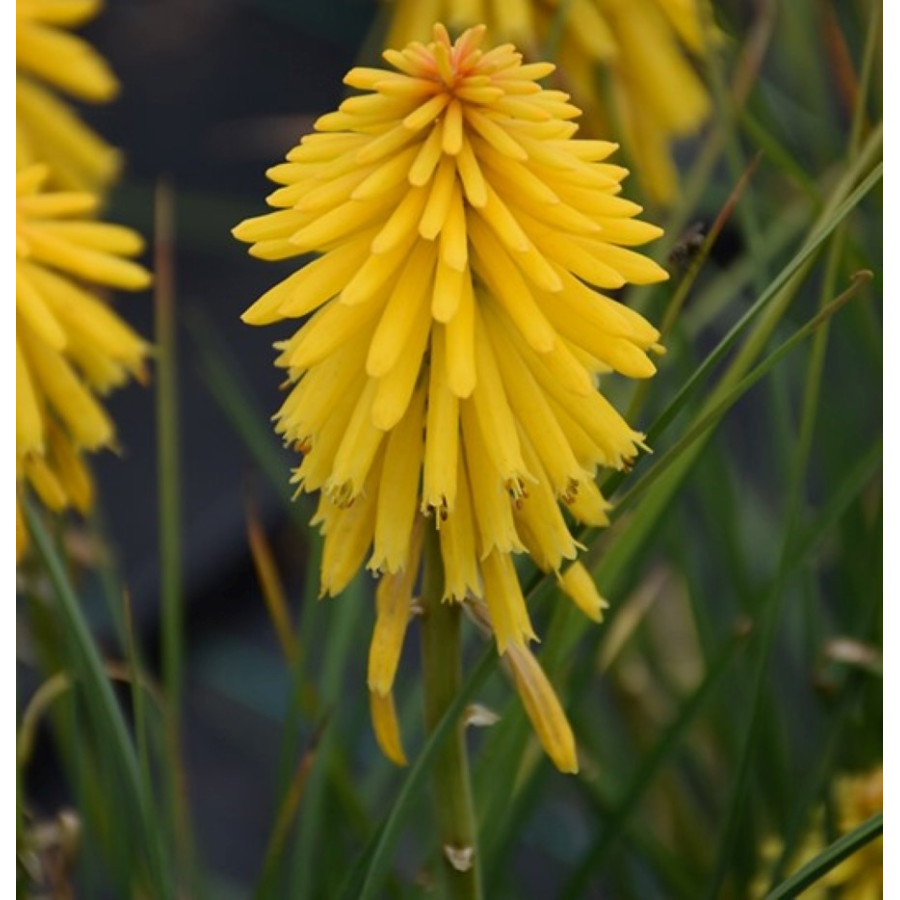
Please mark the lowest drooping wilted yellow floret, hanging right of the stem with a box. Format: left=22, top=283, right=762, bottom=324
left=507, top=646, right=578, bottom=774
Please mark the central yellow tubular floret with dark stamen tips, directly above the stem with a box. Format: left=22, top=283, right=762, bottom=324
left=422, top=326, right=459, bottom=512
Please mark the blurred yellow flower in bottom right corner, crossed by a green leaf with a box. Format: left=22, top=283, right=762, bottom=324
left=750, top=765, right=884, bottom=900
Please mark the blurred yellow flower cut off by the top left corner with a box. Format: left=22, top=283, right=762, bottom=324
left=16, top=0, right=120, bottom=190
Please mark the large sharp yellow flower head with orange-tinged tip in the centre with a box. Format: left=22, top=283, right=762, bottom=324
left=235, top=25, right=666, bottom=769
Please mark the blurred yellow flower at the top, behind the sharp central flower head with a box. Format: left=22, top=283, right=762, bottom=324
left=380, top=0, right=710, bottom=203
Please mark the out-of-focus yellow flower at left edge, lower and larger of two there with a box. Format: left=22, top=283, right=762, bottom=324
left=16, top=165, right=150, bottom=557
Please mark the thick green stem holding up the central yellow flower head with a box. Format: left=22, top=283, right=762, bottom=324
left=422, top=531, right=482, bottom=900
